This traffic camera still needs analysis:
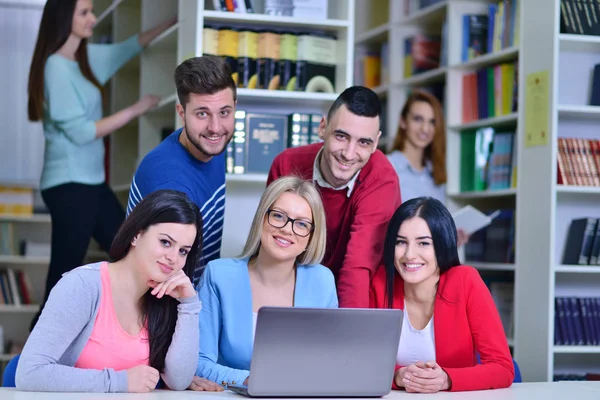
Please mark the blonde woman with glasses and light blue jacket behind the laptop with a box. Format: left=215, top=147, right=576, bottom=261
left=190, top=176, right=338, bottom=390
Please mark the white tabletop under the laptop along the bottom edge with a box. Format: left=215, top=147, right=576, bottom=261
left=0, top=382, right=600, bottom=400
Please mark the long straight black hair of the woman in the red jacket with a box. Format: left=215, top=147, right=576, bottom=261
left=383, top=197, right=460, bottom=308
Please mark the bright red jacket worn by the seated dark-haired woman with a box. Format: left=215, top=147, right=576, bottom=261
left=370, top=265, right=515, bottom=392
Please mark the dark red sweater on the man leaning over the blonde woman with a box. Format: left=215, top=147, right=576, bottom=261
left=267, top=143, right=400, bottom=308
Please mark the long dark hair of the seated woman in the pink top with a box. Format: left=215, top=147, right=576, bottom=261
left=110, top=190, right=202, bottom=371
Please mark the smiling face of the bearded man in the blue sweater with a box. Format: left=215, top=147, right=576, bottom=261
left=177, top=88, right=235, bottom=162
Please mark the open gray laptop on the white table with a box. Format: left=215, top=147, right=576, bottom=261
left=227, top=307, right=403, bottom=397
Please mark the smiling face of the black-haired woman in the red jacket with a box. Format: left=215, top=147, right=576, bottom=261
left=394, top=216, right=440, bottom=285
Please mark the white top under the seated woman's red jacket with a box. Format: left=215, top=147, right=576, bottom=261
left=396, top=303, right=435, bottom=366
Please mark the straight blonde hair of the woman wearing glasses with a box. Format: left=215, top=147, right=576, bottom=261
left=240, top=175, right=327, bottom=265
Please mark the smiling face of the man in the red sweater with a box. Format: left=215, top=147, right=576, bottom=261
left=319, top=105, right=381, bottom=187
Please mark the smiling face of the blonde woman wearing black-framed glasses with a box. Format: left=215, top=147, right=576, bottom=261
left=259, top=192, right=313, bottom=262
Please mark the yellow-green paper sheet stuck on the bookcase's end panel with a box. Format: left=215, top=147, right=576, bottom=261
left=525, top=70, right=550, bottom=147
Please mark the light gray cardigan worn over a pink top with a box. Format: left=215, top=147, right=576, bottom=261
left=16, top=263, right=202, bottom=392
